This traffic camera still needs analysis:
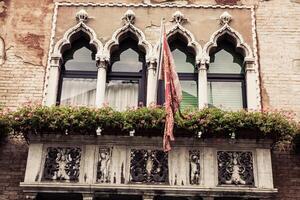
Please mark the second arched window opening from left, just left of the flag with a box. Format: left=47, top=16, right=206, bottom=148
left=105, top=34, right=147, bottom=110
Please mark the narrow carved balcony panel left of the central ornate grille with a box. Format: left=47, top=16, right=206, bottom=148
left=97, top=148, right=112, bottom=183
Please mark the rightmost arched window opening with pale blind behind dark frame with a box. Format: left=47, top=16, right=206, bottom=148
left=207, top=39, right=247, bottom=110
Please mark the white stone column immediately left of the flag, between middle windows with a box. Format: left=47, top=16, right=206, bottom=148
left=147, top=61, right=157, bottom=106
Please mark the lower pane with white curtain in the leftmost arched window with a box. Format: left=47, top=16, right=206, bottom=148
left=60, top=78, right=97, bottom=106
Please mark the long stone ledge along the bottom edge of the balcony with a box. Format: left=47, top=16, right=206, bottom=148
left=20, top=182, right=278, bottom=198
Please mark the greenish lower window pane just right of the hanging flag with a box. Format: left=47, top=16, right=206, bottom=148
left=180, top=81, right=198, bottom=109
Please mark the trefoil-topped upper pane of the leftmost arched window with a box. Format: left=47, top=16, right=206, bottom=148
left=65, top=47, right=97, bottom=71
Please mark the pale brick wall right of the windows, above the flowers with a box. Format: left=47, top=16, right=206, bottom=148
left=256, top=0, right=300, bottom=117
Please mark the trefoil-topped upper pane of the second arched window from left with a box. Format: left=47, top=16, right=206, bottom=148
left=112, top=48, right=143, bottom=72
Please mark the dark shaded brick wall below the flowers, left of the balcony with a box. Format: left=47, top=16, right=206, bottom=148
left=0, top=138, right=28, bottom=200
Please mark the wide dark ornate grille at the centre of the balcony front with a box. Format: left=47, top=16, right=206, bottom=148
left=130, top=149, right=169, bottom=183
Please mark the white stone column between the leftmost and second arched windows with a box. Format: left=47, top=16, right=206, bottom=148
left=95, top=60, right=108, bottom=108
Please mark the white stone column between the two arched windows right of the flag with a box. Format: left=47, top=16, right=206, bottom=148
left=198, top=62, right=208, bottom=109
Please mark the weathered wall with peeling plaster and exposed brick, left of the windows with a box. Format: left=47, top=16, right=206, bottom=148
left=0, top=0, right=53, bottom=108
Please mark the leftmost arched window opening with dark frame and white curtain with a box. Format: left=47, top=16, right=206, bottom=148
left=57, top=34, right=97, bottom=106
